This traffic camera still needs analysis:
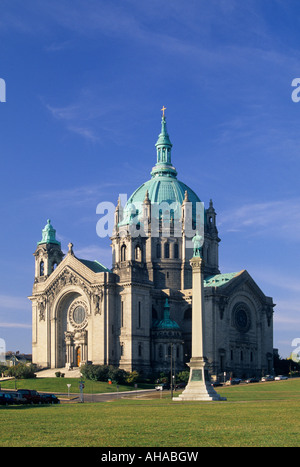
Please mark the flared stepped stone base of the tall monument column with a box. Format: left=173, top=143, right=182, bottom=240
left=173, top=358, right=226, bottom=401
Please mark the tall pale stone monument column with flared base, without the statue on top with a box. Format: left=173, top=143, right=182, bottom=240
left=173, top=256, right=226, bottom=401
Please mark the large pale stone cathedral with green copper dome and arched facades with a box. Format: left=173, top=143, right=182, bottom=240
left=29, top=113, right=274, bottom=377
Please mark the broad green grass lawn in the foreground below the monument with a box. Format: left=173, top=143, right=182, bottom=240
left=0, top=379, right=300, bottom=447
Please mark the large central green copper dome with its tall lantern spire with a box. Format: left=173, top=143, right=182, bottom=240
left=119, top=111, right=200, bottom=225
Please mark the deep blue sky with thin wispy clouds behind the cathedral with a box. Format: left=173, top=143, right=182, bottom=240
left=0, top=0, right=300, bottom=357
